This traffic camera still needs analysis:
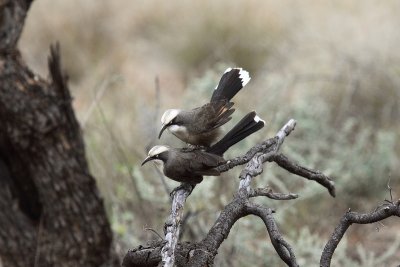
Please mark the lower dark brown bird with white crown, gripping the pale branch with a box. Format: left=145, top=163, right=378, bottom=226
left=142, top=111, right=265, bottom=184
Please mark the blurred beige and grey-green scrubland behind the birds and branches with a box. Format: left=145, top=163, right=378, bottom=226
left=20, top=0, right=400, bottom=266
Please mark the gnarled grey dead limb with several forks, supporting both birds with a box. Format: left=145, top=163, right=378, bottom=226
left=123, top=120, right=334, bottom=267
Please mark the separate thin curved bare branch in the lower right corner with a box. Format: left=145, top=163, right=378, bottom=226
left=320, top=200, right=400, bottom=267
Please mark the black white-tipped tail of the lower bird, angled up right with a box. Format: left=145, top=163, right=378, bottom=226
left=207, top=111, right=265, bottom=156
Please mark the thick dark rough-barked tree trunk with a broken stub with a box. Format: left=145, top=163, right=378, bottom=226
left=0, top=0, right=118, bottom=267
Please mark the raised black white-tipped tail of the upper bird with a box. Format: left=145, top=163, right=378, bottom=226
left=210, top=68, right=250, bottom=103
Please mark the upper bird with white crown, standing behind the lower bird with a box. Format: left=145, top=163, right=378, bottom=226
left=158, top=68, right=250, bottom=147
